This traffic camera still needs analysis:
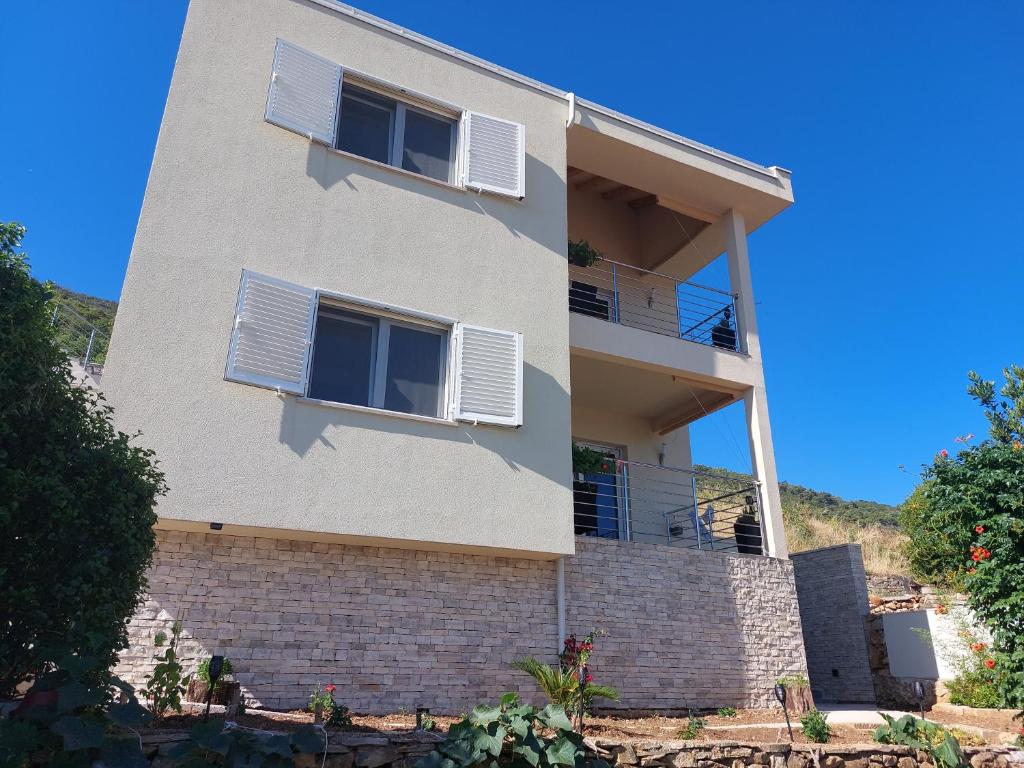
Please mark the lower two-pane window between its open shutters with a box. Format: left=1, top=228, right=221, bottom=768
left=307, top=303, right=449, bottom=418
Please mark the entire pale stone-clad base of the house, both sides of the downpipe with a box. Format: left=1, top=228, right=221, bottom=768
left=117, top=530, right=806, bottom=714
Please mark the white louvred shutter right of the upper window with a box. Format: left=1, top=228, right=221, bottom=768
left=462, top=112, right=526, bottom=198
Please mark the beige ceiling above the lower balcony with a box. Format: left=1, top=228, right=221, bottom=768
left=569, top=354, right=740, bottom=434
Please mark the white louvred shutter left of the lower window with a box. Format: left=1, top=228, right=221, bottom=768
left=224, top=269, right=316, bottom=394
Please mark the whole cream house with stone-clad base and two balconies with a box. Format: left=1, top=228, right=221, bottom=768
left=103, top=0, right=806, bottom=712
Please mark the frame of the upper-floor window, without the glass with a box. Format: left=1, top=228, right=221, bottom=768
left=332, top=77, right=465, bottom=186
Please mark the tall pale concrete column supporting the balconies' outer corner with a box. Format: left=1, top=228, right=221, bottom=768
left=722, top=211, right=790, bottom=558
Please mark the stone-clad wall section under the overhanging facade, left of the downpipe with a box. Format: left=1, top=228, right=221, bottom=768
left=116, top=530, right=558, bottom=713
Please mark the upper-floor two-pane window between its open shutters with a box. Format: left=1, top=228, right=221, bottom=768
left=337, top=81, right=457, bottom=182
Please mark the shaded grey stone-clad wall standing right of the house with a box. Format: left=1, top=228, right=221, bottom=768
left=792, top=544, right=874, bottom=703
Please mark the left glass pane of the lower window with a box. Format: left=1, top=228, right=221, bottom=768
left=309, top=310, right=377, bottom=406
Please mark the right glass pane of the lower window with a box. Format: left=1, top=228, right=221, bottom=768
left=384, top=325, right=444, bottom=416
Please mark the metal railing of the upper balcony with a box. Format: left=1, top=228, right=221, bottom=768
left=569, top=259, right=740, bottom=350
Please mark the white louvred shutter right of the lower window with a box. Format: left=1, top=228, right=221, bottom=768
left=455, top=323, right=522, bottom=427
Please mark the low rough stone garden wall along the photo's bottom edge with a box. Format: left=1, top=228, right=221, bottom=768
left=142, top=731, right=1024, bottom=768
